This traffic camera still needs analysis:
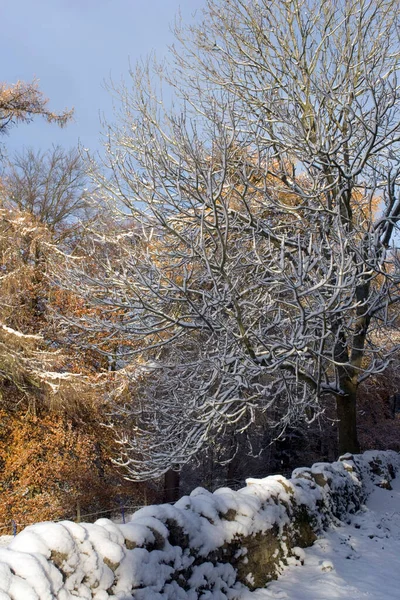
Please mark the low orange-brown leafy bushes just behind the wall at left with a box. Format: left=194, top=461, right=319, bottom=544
left=0, top=409, right=158, bottom=533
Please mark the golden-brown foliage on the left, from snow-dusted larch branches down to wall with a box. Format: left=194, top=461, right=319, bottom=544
left=0, top=195, right=161, bottom=533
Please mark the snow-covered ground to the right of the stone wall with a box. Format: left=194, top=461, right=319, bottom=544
left=241, top=476, right=400, bottom=600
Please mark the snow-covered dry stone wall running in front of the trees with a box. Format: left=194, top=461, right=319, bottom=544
left=0, top=452, right=400, bottom=600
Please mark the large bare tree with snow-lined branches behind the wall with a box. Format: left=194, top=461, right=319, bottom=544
left=59, top=0, right=400, bottom=479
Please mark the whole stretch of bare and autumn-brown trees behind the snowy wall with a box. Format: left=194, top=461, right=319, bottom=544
left=0, top=0, right=400, bottom=533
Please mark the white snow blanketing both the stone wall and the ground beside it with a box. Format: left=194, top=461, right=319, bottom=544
left=0, top=452, right=400, bottom=600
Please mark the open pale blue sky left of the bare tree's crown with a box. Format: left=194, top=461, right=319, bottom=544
left=0, top=0, right=206, bottom=155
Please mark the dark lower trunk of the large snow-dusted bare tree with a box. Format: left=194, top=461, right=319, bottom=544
left=336, top=381, right=360, bottom=455
